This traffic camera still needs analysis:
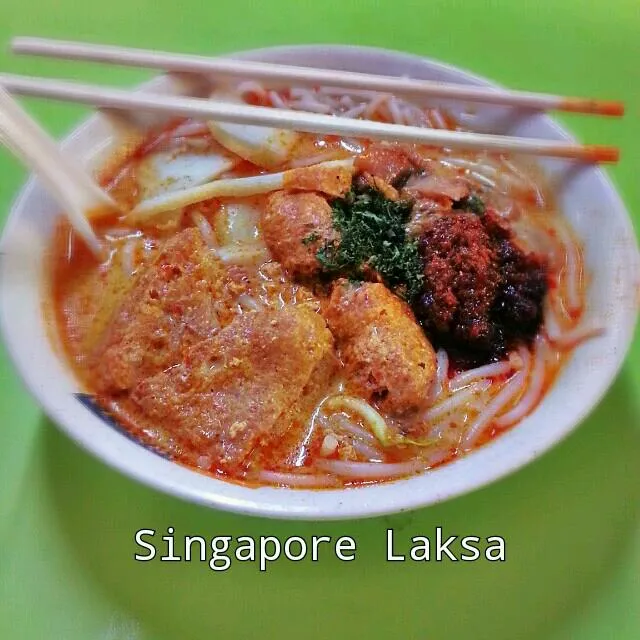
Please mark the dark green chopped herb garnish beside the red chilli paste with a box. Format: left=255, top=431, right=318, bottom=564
left=316, top=187, right=424, bottom=302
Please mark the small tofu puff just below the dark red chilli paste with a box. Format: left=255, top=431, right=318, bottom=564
left=325, top=280, right=436, bottom=415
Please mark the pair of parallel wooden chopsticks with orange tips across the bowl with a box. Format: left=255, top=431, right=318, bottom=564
left=0, top=38, right=624, bottom=162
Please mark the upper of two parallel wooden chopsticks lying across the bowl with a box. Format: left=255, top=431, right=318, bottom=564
left=11, top=37, right=624, bottom=116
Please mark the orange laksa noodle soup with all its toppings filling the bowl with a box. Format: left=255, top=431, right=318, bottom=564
left=47, top=83, right=594, bottom=489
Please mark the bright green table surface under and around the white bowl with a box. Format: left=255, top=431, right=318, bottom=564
left=0, top=0, right=640, bottom=640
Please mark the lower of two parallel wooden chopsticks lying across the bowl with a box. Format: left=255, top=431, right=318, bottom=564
left=0, top=74, right=619, bottom=162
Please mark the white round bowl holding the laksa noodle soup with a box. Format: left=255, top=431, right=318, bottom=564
left=0, top=46, right=640, bottom=519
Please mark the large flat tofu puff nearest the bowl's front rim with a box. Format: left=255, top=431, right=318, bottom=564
left=132, top=306, right=336, bottom=471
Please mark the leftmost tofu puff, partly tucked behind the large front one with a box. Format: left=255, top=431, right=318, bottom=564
left=91, top=228, right=227, bottom=393
